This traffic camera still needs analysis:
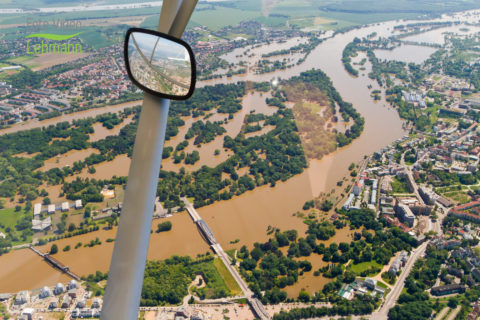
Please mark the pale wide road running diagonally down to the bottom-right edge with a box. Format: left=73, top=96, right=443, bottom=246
left=370, top=242, right=428, bottom=320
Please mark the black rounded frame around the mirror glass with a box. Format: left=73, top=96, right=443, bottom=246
left=123, top=28, right=197, bottom=100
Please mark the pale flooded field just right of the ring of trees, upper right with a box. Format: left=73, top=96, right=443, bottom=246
left=375, top=44, right=437, bottom=64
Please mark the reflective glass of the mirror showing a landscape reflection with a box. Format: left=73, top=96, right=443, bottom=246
left=128, top=32, right=192, bottom=97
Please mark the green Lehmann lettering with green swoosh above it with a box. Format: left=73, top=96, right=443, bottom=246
left=25, top=32, right=83, bottom=54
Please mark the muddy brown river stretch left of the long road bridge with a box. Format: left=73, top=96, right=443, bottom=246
left=0, top=212, right=209, bottom=292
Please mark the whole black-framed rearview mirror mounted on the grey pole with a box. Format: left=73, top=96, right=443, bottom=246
left=124, top=28, right=196, bottom=100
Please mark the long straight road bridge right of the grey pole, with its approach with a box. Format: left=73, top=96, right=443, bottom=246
left=181, top=197, right=270, bottom=320
